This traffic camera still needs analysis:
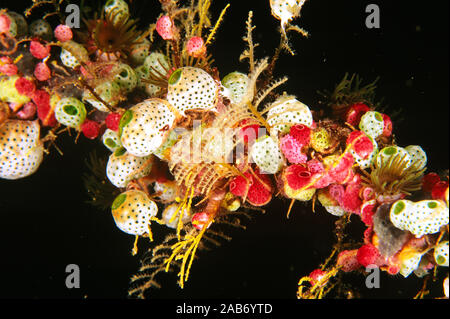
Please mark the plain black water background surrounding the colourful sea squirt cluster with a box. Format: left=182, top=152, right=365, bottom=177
left=0, top=0, right=449, bottom=299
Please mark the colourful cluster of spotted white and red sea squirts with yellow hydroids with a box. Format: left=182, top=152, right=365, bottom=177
left=0, top=0, right=448, bottom=298
